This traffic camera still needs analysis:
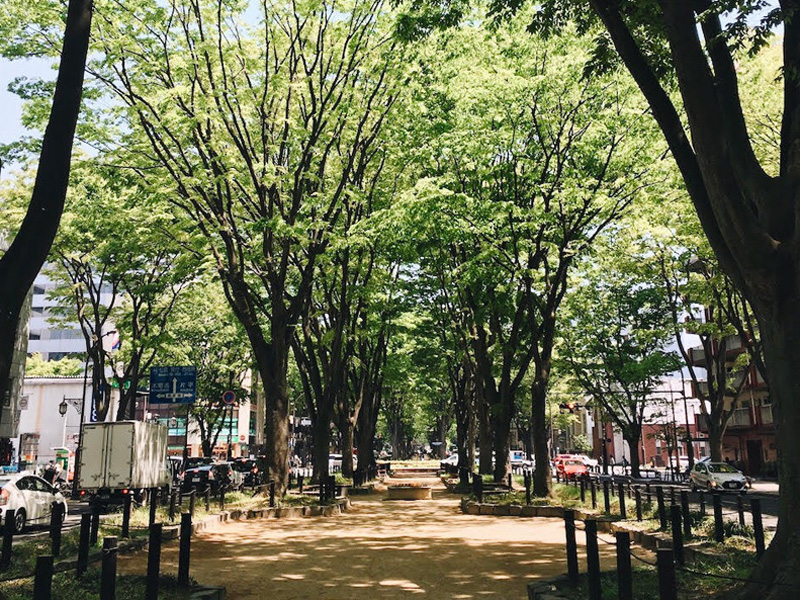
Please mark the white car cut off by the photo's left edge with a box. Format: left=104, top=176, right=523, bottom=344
left=0, top=471, right=67, bottom=533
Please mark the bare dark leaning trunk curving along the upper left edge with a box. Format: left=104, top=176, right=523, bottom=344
left=0, top=0, right=92, bottom=408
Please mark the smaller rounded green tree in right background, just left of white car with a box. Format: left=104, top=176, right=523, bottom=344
left=562, top=239, right=680, bottom=477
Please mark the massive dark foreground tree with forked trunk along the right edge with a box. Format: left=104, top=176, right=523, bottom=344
left=495, top=0, right=800, bottom=599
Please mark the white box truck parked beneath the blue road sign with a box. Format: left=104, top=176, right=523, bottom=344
left=78, top=421, right=172, bottom=504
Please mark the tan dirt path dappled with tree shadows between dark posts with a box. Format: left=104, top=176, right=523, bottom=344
left=120, top=491, right=614, bottom=600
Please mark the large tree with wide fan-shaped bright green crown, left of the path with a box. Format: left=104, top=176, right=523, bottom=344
left=94, top=0, right=410, bottom=490
